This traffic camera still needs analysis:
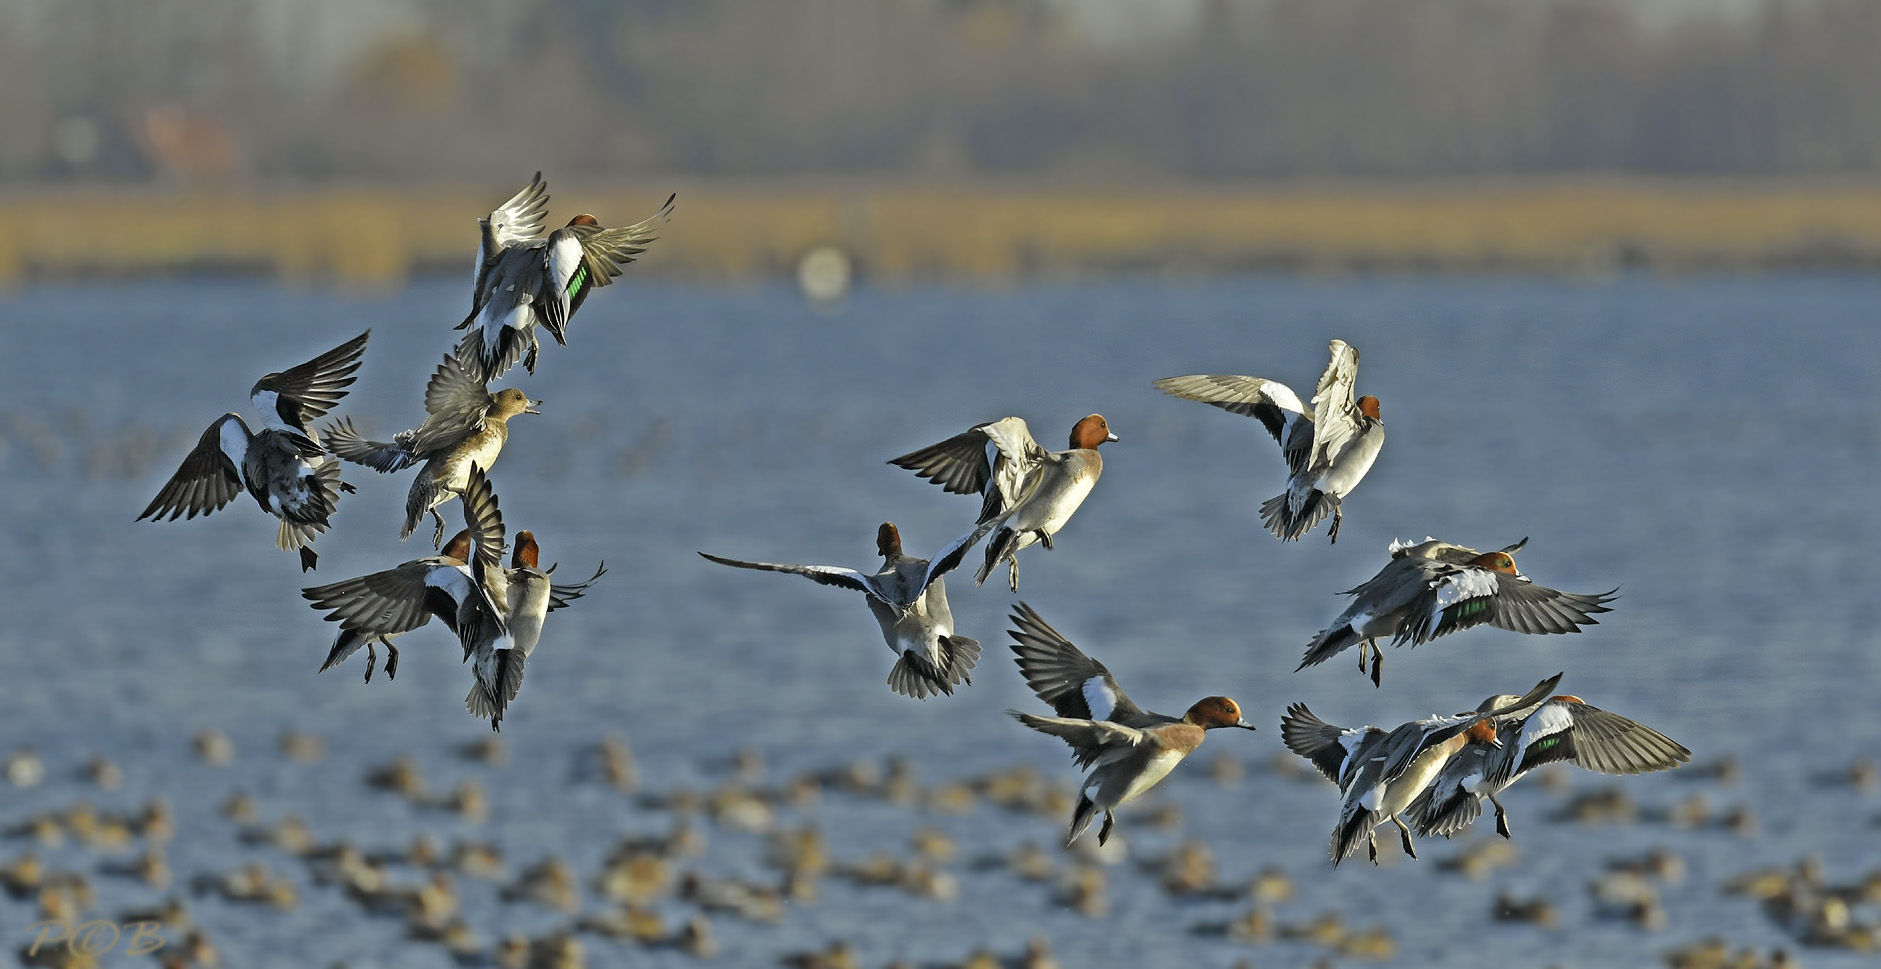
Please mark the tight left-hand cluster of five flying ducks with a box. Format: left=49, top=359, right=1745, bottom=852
left=137, top=171, right=673, bottom=728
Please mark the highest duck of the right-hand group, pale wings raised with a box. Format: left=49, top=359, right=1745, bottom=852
left=1155, top=341, right=1384, bottom=542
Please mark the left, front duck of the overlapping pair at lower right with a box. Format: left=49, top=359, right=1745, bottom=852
left=1281, top=674, right=1561, bottom=867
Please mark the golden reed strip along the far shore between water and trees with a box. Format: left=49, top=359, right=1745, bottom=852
left=0, top=177, right=1881, bottom=288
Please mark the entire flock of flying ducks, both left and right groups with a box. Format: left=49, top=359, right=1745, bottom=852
left=139, top=173, right=1691, bottom=864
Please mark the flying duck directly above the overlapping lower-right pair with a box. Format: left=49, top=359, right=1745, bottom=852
left=1296, top=538, right=1620, bottom=685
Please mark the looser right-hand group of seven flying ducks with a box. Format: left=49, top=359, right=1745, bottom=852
left=700, top=339, right=1691, bottom=866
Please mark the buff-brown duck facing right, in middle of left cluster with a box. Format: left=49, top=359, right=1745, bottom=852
left=325, top=346, right=542, bottom=546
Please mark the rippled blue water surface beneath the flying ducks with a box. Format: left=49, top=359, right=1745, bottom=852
left=0, top=278, right=1881, bottom=967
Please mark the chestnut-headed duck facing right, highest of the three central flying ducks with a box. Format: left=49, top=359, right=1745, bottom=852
left=890, top=414, right=1117, bottom=593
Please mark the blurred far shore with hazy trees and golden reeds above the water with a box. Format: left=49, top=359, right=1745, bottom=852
left=0, top=0, right=1881, bottom=284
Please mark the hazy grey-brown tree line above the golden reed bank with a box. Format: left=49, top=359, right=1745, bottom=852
left=0, top=0, right=1881, bottom=184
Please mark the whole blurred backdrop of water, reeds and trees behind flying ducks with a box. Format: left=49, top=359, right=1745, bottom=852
left=0, top=0, right=1881, bottom=969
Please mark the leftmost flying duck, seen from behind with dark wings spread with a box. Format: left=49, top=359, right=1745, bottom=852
left=137, top=329, right=372, bottom=572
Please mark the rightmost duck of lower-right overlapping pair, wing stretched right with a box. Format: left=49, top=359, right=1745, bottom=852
left=1405, top=694, right=1691, bottom=837
